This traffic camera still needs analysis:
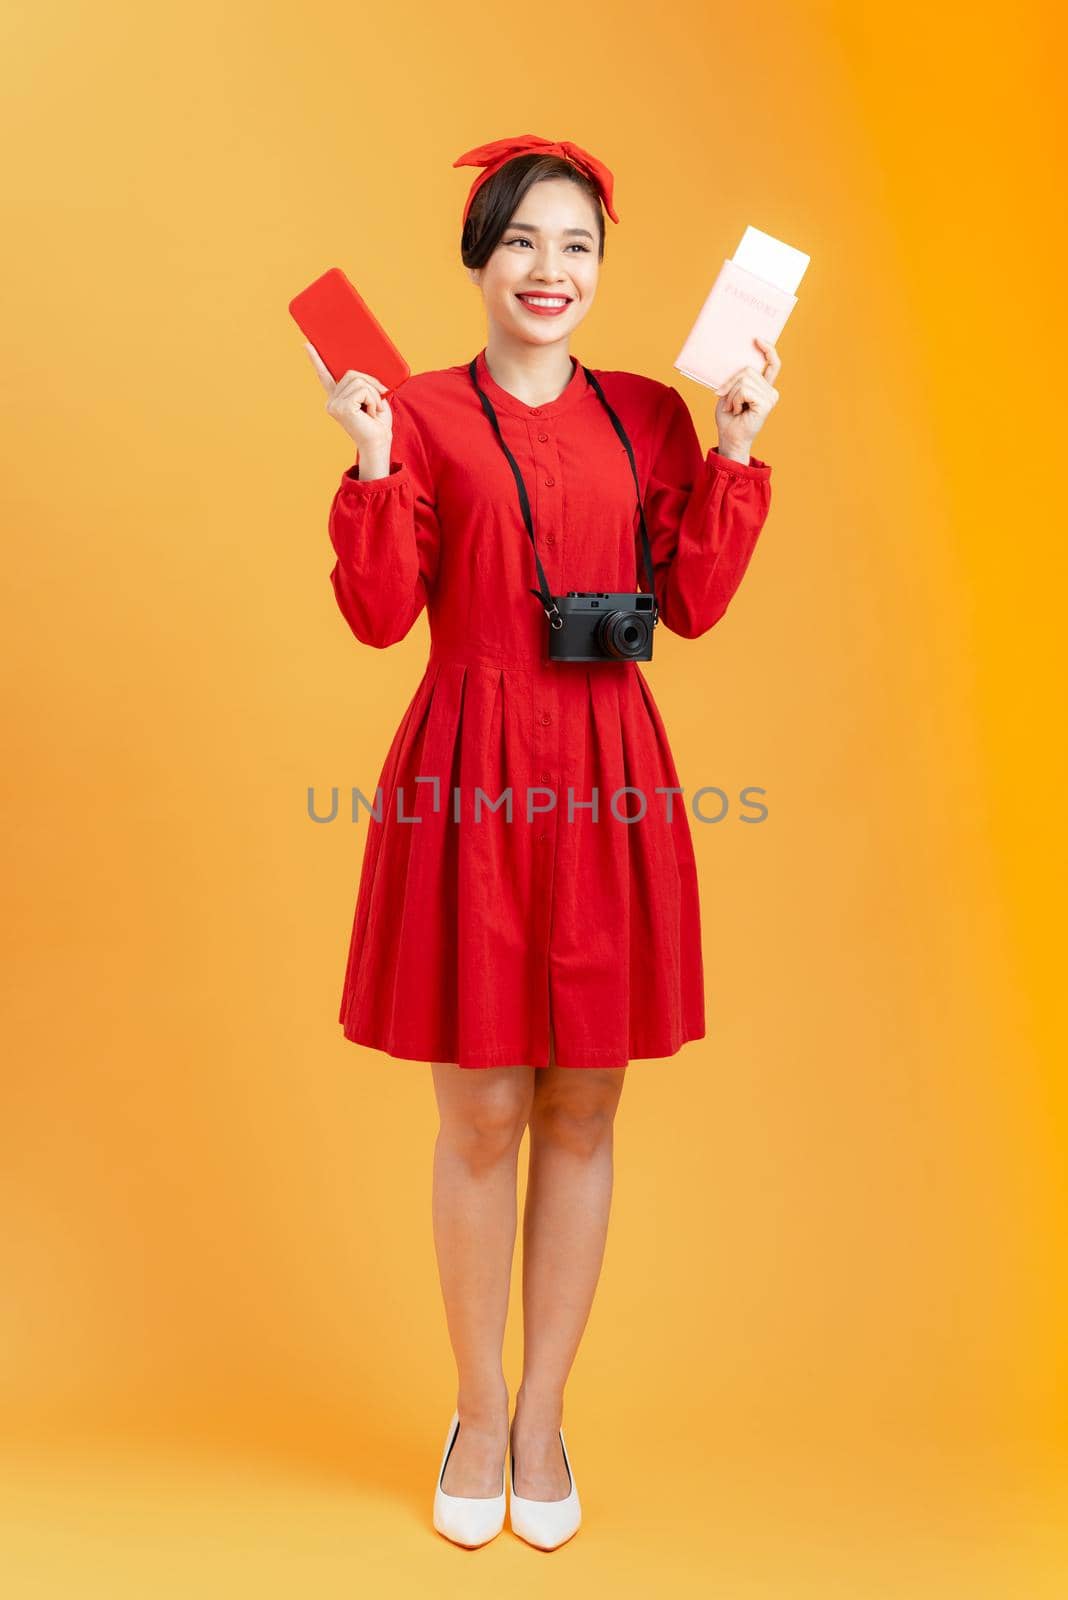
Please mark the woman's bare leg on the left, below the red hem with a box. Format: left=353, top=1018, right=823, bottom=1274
left=432, top=1061, right=534, bottom=1496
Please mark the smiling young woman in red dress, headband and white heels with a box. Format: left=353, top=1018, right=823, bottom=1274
left=307, top=134, right=780, bottom=1549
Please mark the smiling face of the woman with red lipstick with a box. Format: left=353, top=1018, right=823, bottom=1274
left=467, top=178, right=601, bottom=344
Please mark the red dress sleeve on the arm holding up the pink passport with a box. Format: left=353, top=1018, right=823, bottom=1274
left=635, top=387, right=771, bottom=638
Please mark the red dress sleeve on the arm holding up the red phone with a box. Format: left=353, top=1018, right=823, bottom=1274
left=329, top=395, right=440, bottom=650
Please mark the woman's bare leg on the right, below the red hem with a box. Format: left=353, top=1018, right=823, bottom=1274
left=512, top=1064, right=627, bottom=1499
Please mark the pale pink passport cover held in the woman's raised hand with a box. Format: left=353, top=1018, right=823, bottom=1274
left=673, top=259, right=798, bottom=394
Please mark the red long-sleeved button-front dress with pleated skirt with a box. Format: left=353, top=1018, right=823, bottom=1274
left=329, top=349, right=771, bottom=1067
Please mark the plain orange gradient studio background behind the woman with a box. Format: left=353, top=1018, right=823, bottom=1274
left=0, top=0, right=1068, bottom=1600
